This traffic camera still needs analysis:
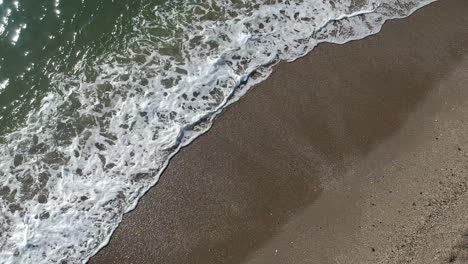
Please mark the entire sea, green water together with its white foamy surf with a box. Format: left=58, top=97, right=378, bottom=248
left=0, top=0, right=435, bottom=264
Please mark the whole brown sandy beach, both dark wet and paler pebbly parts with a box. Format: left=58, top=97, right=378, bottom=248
left=90, top=0, right=468, bottom=264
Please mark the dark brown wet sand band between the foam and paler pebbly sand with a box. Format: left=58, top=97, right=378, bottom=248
left=90, top=0, right=468, bottom=264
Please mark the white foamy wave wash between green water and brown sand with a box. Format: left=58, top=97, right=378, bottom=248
left=0, top=0, right=433, bottom=263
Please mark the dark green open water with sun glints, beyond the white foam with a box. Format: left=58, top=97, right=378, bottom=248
left=0, top=0, right=148, bottom=133
